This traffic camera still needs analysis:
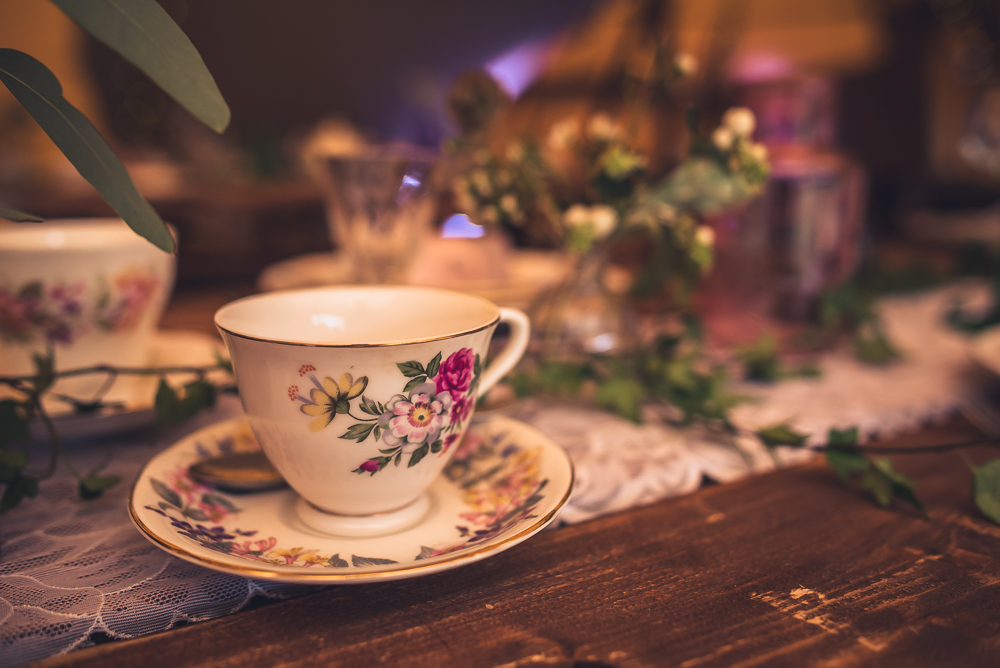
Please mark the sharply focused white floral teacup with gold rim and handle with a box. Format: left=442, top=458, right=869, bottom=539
left=215, top=286, right=530, bottom=536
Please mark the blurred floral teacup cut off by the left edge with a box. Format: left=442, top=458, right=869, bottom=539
left=0, top=218, right=175, bottom=398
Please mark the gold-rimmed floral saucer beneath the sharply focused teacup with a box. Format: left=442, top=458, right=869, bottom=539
left=129, top=417, right=573, bottom=584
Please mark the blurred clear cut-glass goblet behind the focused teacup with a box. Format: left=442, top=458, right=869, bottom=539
left=317, top=147, right=436, bottom=283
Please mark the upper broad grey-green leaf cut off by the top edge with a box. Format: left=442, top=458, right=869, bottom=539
left=52, top=0, right=230, bottom=132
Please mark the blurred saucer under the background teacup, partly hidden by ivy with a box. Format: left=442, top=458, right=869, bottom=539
left=20, top=330, right=226, bottom=440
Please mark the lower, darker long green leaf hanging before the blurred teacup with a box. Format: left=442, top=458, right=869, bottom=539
left=0, top=49, right=174, bottom=253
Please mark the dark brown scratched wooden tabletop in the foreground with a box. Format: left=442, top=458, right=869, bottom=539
left=39, top=290, right=1000, bottom=668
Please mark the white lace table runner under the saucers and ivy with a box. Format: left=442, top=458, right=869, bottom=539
left=0, top=288, right=983, bottom=666
